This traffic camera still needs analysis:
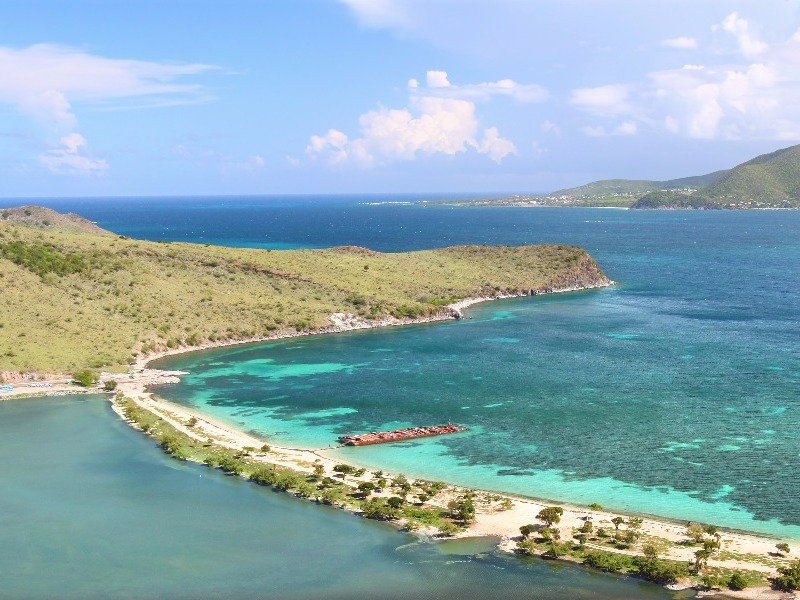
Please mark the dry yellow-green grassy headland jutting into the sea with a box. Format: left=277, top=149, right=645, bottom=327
left=0, top=207, right=607, bottom=373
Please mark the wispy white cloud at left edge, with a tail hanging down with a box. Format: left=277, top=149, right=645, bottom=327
left=0, top=44, right=216, bottom=173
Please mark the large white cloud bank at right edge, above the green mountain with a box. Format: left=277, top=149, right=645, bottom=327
left=570, top=13, right=800, bottom=140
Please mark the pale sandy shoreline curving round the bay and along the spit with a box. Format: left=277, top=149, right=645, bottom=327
left=0, top=280, right=794, bottom=599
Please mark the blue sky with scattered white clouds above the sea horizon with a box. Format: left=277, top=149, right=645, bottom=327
left=0, top=0, right=800, bottom=198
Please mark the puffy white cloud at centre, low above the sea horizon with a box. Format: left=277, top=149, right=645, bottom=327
left=306, top=71, right=517, bottom=168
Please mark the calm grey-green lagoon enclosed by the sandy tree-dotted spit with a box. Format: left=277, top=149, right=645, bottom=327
left=0, top=396, right=685, bottom=600
